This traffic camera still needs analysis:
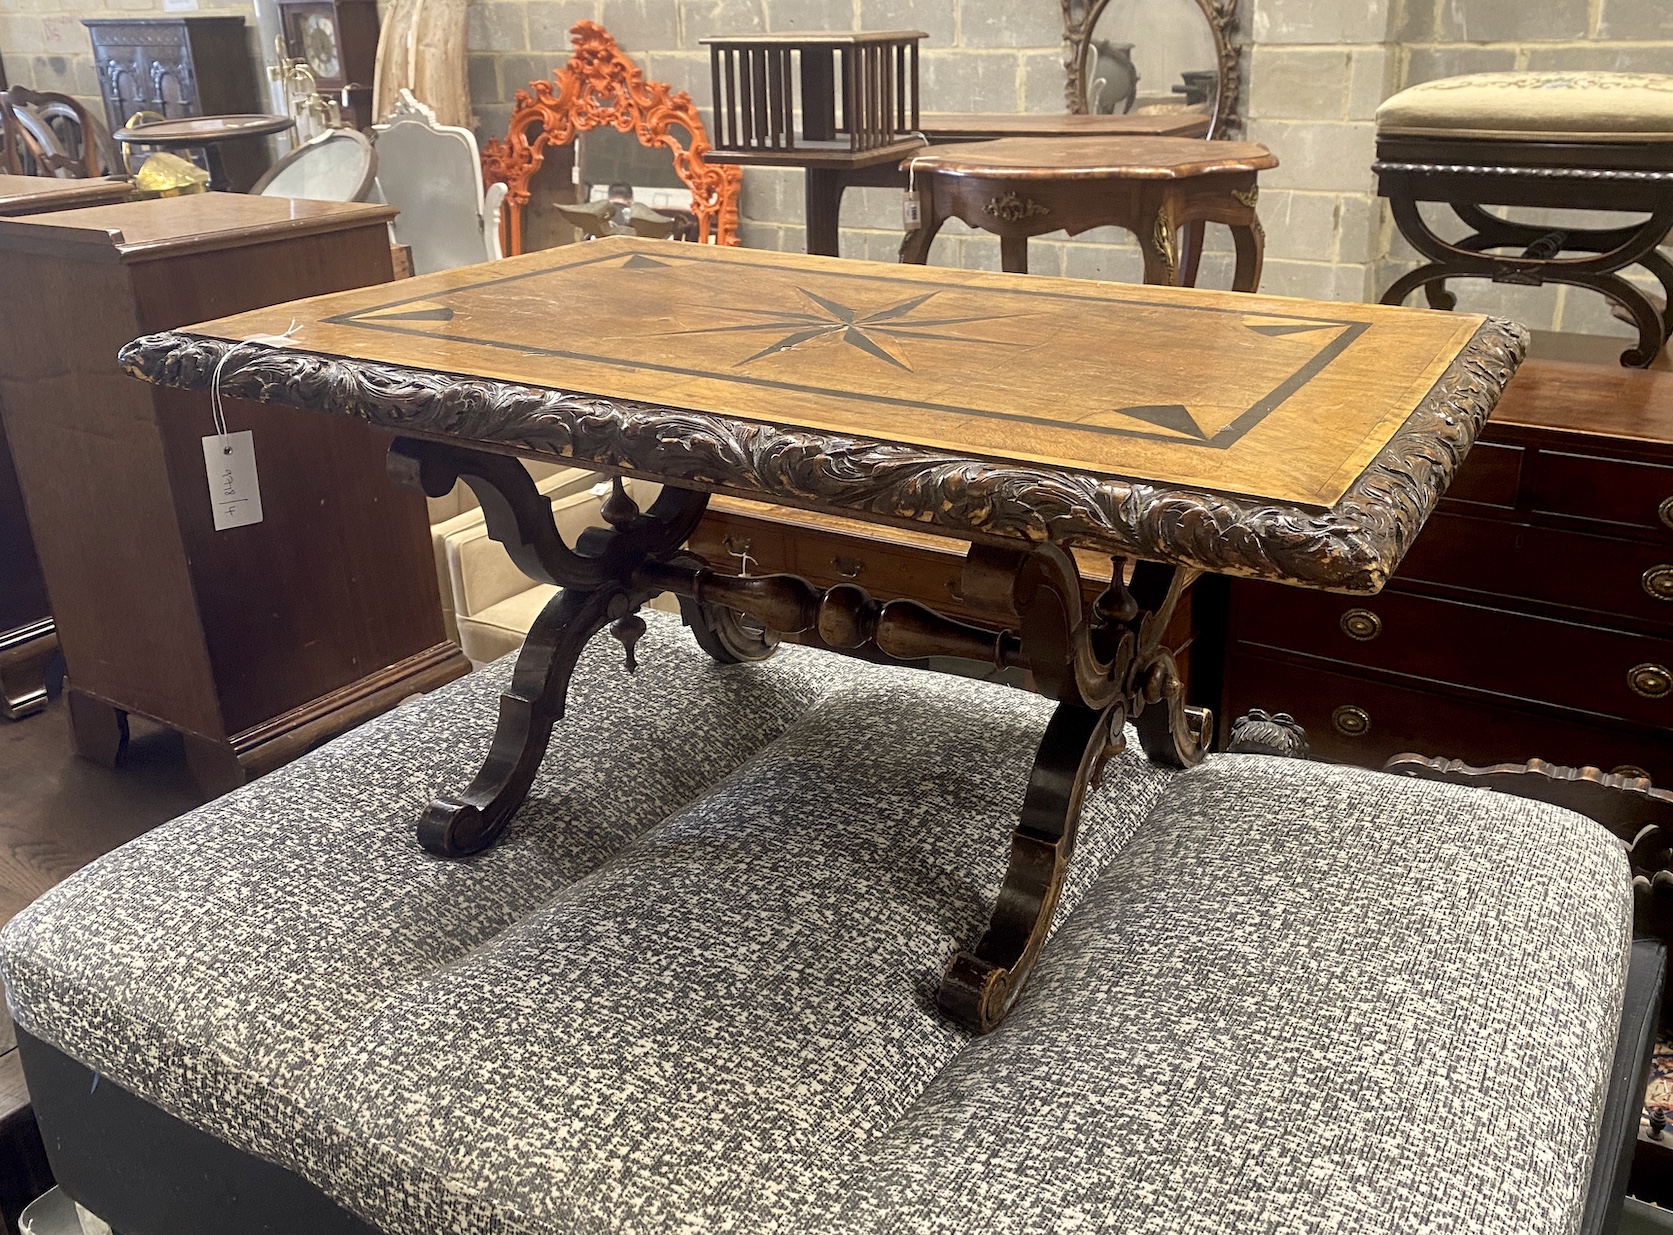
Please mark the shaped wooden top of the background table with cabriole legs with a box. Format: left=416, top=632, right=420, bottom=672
left=900, top=136, right=1278, bottom=181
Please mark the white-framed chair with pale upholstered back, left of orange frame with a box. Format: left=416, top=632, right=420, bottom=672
left=373, top=89, right=505, bottom=274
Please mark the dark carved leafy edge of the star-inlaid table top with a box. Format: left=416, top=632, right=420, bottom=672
left=120, top=318, right=1527, bottom=594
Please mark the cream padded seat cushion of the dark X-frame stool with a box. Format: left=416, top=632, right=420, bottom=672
left=1377, top=72, right=1673, bottom=142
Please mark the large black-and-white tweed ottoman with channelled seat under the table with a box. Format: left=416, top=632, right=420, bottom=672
left=0, top=614, right=1660, bottom=1235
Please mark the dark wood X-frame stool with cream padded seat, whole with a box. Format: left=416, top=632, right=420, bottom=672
left=1375, top=72, right=1673, bottom=366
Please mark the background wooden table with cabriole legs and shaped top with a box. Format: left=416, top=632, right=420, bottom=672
left=900, top=137, right=1278, bottom=291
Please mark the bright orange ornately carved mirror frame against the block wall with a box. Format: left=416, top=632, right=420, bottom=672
left=482, top=22, right=743, bottom=256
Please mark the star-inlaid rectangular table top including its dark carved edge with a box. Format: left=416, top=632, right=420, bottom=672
left=124, top=238, right=1526, bottom=591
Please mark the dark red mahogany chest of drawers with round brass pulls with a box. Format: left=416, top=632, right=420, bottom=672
left=1221, top=361, right=1673, bottom=785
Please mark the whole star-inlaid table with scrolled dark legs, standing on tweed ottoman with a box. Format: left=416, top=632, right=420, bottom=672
left=122, top=239, right=1526, bottom=1031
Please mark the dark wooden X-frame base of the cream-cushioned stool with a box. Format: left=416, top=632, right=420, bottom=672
left=1372, top=136, right=1673, bottom=368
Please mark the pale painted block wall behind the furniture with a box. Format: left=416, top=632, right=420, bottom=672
left=0, top=0, right=1673, bottom=335
